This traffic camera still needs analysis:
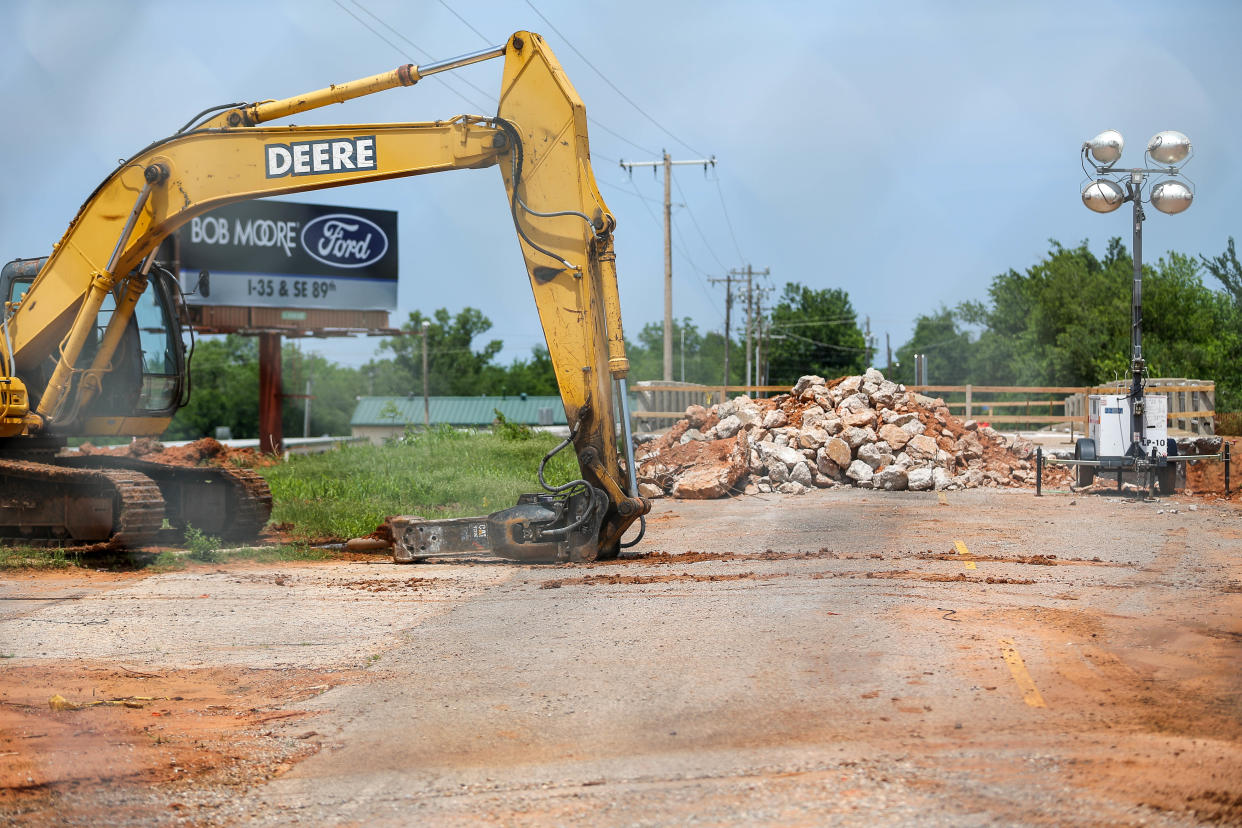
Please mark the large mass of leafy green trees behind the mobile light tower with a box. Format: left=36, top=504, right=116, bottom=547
left=898, top=238, right=1242, bottom=410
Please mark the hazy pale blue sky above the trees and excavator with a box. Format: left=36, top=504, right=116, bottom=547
left=0, top=0, right=1242, bottom=374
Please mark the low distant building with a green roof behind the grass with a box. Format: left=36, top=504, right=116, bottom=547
left=349, top=395, right=569, bottom=446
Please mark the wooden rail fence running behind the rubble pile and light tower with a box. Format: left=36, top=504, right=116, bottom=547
left=631, top=379, right=1216, bottom=434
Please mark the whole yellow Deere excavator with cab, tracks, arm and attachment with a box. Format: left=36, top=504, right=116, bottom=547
left=0, top=31, right=650, bottom=561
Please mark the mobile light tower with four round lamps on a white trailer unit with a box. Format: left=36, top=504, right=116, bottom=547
left=1074, top=129, right=1195, bottom=494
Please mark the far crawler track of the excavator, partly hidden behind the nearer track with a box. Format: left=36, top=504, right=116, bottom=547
left=56, top=454, right=272, bottom=541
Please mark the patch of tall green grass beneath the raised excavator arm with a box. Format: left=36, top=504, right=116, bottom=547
left=256, top=428, right=579, bottom=539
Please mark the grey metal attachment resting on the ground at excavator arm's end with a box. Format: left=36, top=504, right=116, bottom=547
left=389, top=487, right=609, bottom=564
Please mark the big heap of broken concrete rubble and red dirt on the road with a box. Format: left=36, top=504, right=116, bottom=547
left=636, top=369, right=1069, bottom=499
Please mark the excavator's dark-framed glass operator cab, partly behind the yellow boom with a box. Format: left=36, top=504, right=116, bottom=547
left=0, top=258, right=186, bottom=436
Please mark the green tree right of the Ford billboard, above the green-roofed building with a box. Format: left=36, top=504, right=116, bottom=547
left=380, top=308, right=503, bottom=396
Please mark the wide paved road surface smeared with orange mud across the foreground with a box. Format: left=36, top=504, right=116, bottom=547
left=0, top=489, right=1242, bottom=826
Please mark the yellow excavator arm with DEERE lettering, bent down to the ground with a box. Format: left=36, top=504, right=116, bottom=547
left=0, top=32, right=650, bottom=559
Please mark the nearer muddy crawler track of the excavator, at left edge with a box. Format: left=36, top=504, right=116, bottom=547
left=0, top=461, right=164, bottom=549
